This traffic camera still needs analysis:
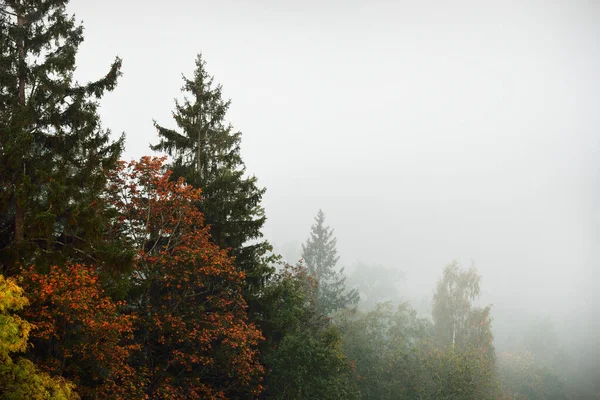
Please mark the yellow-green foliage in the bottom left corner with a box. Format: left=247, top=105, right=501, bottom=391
left=0, top=275, right=79, bottom=400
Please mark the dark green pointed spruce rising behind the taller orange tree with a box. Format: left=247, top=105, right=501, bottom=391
left=151, top=54, right=274, bottom=303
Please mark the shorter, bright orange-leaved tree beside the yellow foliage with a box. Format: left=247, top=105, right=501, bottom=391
left=22, top=264, right=140, bottom=399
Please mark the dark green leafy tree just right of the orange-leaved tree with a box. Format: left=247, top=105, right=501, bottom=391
left=260, top=266, right=358, bottom=399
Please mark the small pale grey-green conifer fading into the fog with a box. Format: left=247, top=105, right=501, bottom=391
left=302, top=210, right=359, bottom=314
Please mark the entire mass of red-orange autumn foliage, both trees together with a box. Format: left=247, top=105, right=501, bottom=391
left=11, top=157, right=264, bottom=399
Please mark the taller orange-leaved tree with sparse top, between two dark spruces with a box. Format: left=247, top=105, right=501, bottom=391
left=109, top=157, right=263, bottom=399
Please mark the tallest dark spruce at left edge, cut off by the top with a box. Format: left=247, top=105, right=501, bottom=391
left=0, top=0, right=123, bottom=275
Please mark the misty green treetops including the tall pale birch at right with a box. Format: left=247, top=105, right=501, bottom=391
left=336, top=266, right=500, bottom=400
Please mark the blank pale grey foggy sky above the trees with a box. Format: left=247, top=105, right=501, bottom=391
left=70, top=0, right=600, bottom=356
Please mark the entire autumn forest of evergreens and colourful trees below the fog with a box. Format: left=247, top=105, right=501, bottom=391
left=0, top=0, right=600, bottom=400
